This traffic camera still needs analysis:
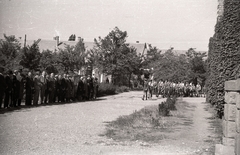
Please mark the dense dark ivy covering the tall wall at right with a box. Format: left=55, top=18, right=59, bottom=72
left=206, top=0, right=240, bottom=117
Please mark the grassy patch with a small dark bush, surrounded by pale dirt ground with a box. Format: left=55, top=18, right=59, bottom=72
left=102, top=98, right=183, bottom=142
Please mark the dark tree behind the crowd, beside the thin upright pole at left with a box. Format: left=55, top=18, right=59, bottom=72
left=20, top=44, right=41, bottom=71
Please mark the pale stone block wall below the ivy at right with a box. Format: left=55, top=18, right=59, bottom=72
left=215, top=79, right=240, bottom=155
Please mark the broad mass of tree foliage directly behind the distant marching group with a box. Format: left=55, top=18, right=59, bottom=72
left=144, top=48, right=206, bottom=85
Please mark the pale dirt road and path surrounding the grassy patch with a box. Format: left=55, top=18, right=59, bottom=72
left=0, top=91, right=219, bottom=155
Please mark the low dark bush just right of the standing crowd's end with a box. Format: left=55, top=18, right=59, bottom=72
left=98, top=83, right=116, bottom=96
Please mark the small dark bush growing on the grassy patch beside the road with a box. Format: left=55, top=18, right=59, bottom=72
left=158, top=97, right=177, bottom=116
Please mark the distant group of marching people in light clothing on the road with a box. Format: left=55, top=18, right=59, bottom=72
left=142, top=78, right=205, bottom=100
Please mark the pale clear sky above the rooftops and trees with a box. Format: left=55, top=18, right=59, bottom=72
left=0, top=0, right=218, bottom=51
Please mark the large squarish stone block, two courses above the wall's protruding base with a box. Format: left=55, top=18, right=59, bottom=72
left=223, top=120, right=237, bottom=138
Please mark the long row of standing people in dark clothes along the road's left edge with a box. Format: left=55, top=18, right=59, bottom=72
left=0, top=68, right=98, bottom=108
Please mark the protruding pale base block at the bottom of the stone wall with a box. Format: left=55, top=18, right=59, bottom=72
left=215, top=144, right=235, bottom=155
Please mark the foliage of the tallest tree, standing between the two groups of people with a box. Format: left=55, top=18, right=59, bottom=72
left=94, top=27, right=140, bottom=84
